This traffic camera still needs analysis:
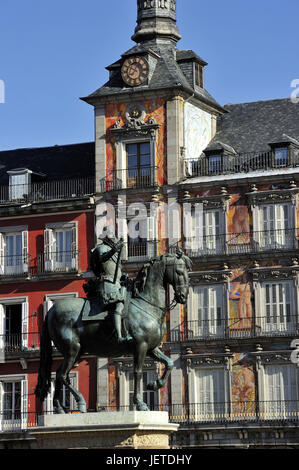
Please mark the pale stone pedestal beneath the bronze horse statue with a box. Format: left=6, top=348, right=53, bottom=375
left=31, top=411, right=179, bottom=449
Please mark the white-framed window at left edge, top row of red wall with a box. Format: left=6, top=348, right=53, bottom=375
left=0, top=230, right=28, bottom=276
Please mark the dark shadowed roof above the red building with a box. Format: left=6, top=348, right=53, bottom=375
left=0, top=142, right=95, bottom=185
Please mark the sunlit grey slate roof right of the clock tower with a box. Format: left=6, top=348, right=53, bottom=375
left=208, top=98, right=299, bottom=153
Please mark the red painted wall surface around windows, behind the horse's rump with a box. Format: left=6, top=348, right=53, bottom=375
left=0, top=203, right=96, bottom=418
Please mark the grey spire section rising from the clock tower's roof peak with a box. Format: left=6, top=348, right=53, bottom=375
left=132, top=0, right=181, bottom=43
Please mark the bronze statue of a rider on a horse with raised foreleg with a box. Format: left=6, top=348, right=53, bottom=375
left=35, top=239, right=191, bottom=413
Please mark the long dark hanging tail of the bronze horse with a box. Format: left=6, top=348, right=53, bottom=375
left=34, top=315, right=52, bottom=402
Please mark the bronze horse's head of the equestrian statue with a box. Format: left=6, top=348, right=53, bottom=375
left=165, top=250, right=192, bottom=304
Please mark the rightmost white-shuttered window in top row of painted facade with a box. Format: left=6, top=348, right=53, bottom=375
left=258, top=204, right=294, bottom=249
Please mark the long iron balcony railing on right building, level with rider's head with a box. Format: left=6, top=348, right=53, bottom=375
left=185, top=228, right=299, bottom=257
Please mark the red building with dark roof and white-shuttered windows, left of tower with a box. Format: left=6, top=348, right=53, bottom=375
left=0, top=144, right=96, bottom=431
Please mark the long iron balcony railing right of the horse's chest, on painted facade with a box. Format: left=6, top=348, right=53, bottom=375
left=176, top=314, right=299, bottom=341
